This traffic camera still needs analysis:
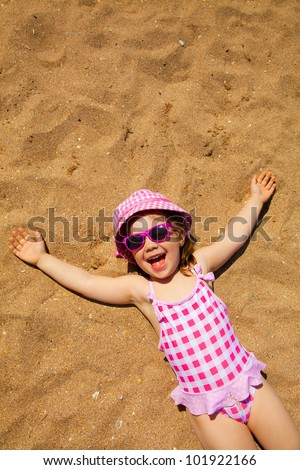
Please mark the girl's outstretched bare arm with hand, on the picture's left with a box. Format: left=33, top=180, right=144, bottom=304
left=9, top=227, right=135, bottom=304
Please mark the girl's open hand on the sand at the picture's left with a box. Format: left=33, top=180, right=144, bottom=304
left=8, top=227, right=47, bottom=265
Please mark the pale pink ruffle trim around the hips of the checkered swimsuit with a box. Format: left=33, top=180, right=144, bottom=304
left=171, top=354, right=266, bottom=415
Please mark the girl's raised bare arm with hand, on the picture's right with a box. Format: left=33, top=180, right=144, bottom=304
left=194, top=171, right=276, bottom=272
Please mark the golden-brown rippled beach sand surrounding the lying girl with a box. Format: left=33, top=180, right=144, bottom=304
left=0, top=0, right=300, bottom=449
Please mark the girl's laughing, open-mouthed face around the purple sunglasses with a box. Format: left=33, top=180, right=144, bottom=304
left=130, top=214, right=185, bottom=280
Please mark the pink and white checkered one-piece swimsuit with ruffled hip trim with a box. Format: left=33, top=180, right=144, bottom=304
left=148, top=264, right=265, bottom=422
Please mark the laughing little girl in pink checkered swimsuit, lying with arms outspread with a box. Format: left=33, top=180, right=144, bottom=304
left=9, top=172, right=300, bottom=450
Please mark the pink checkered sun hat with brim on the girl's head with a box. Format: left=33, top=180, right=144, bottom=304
left=113, top=189, right=192, bottom=262
